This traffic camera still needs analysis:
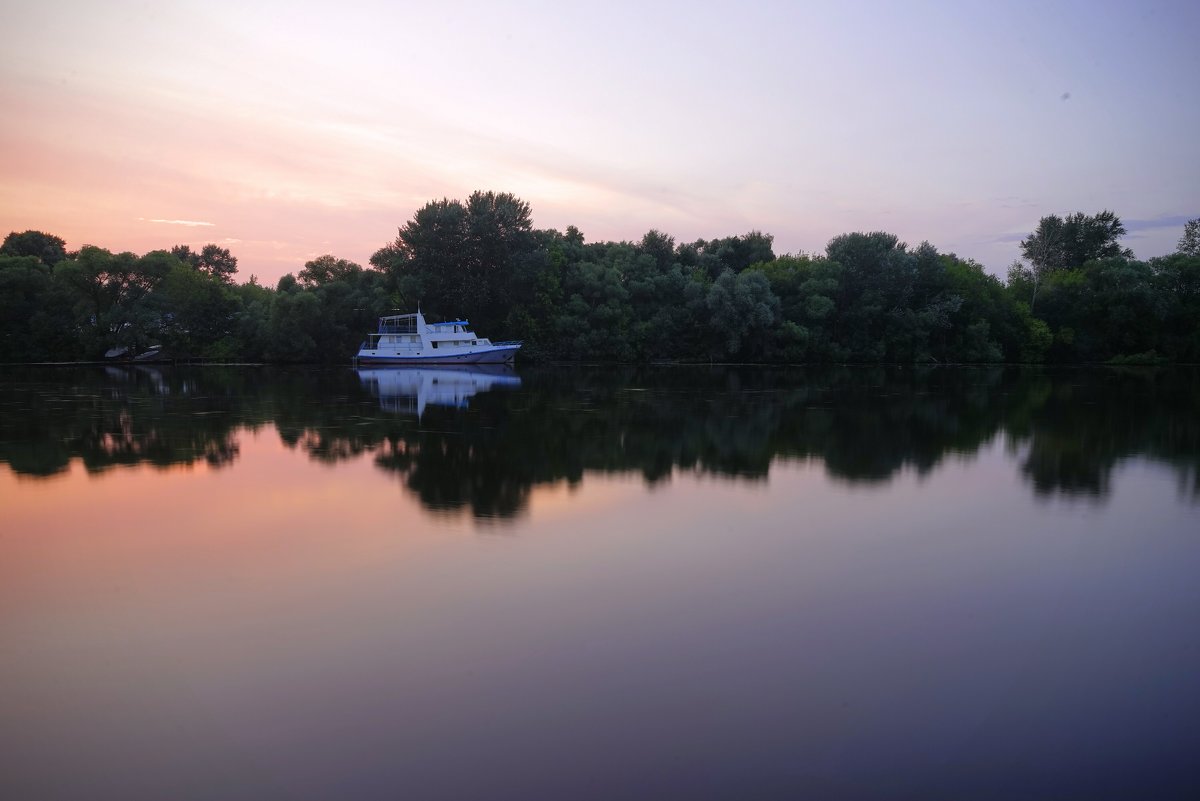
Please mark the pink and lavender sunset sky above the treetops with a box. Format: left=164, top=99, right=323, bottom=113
left=0, top=0, right=1200, bottom=284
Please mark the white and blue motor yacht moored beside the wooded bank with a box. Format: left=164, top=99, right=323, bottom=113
left=354, top=309, right=521, bottom=365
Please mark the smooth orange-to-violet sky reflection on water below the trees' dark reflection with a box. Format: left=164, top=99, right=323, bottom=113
left=0, top=366, right=1200, bottom=799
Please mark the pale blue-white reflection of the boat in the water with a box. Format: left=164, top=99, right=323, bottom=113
left=358, top=365, right=521, bottom=417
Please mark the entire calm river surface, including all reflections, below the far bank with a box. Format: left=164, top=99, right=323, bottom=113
left=0, top=367, right=1200, bottom=801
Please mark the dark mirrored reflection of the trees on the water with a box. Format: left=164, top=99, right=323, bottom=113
left=0, top=367, right=1200, bottom=517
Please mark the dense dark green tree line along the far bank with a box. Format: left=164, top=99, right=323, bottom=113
left=0, top=192, right=1200, bottom=363
